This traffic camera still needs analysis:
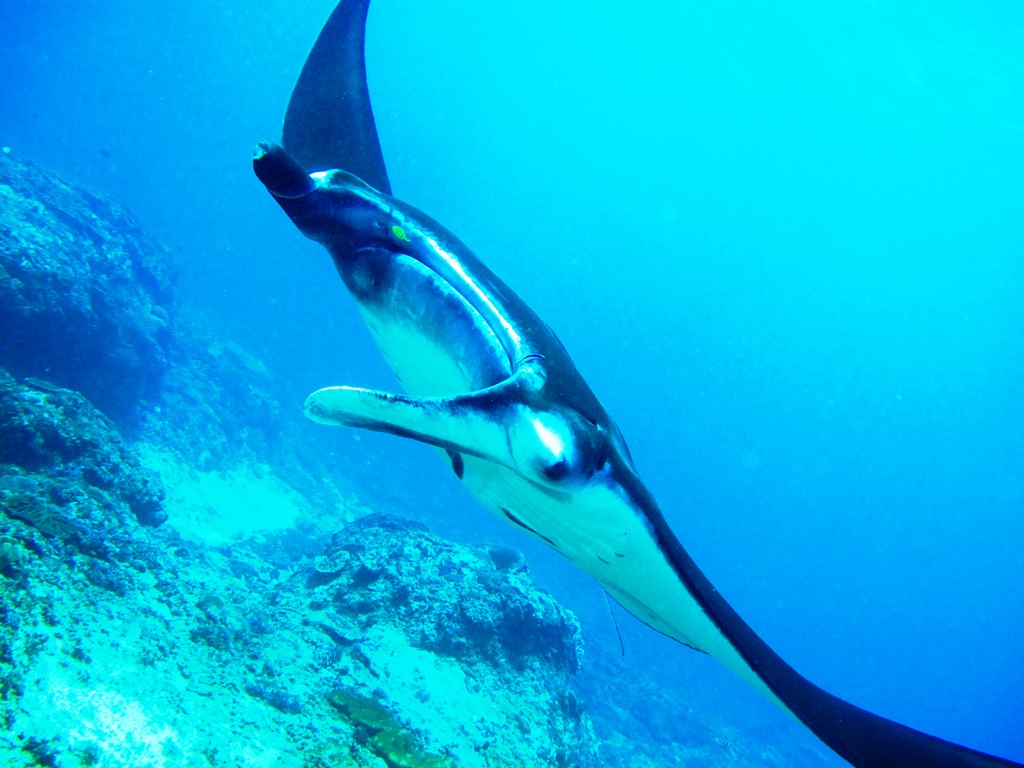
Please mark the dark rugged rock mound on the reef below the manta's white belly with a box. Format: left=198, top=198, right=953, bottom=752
left=309, top=514, right=583, bottom=679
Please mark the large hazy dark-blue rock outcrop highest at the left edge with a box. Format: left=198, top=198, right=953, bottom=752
left=0, top=155, right=175, bottom=417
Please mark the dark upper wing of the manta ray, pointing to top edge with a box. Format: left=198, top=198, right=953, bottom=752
left=282, top=0, right=391, bottom=195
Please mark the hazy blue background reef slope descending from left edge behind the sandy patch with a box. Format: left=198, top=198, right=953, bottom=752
left=0, top=154, right=319, bottom=490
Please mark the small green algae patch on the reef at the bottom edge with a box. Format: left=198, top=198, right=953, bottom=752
left=327, top=688, right=455, bottom=768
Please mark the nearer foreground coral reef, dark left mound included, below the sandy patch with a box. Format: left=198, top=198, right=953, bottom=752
left=0, top=356, right=597, bottom=768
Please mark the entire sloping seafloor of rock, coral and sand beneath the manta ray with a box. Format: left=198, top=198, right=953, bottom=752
left=0, top=156, right=824, bottom=768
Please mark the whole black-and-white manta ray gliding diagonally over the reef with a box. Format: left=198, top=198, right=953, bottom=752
left=253, top=0, right=1021, bottom=768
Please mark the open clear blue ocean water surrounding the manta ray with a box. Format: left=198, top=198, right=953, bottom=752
left=0, top=0, right=1024, bottom=761
